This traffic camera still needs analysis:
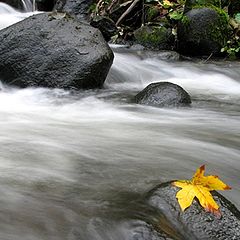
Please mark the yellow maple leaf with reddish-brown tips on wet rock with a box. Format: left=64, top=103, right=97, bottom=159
left=172, top=165, right=231, bottom=216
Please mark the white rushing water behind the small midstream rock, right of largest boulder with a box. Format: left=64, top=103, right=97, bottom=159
left=107, top=53, right=240, bottom=97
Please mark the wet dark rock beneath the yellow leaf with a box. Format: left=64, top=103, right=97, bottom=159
left=147, top=183, right=240, bottom=240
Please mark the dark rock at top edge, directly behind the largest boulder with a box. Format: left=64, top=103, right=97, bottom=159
left=54, top=0, right=94, bottom=20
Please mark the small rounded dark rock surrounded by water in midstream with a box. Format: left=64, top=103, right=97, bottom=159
left=134, top=82, right=191, bottom=107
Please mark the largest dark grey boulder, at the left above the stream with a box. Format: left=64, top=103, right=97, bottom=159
left=0, top=13, right=113, bottom=89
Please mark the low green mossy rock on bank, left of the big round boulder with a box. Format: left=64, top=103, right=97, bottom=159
left=134, top=26, right=174, bottom=50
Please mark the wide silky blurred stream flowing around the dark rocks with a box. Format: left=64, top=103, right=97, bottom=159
left=0, top=2, right=240, bottom=240
